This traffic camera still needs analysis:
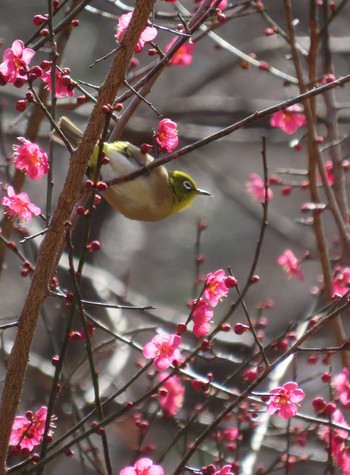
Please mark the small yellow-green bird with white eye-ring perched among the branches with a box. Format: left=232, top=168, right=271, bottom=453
left=51, top=117, right=211, bottom=221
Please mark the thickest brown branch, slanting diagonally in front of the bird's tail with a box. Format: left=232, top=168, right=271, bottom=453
left=0, top=0, right=154, bottom=475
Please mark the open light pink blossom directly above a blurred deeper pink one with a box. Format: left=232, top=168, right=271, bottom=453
left=143, top=333, right=182, bottom=370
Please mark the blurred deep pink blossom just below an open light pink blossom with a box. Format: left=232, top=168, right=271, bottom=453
left=159, top=373, right=185, bottom=417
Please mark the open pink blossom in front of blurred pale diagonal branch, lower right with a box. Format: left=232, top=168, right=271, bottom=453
left=266, top=381, right=305, bottom=419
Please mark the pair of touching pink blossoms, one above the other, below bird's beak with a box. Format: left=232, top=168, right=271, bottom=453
left=190, top=269, right=237, bottom=338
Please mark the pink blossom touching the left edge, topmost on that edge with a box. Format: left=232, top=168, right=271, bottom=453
left=0, top=40, right=35, bottom=83
